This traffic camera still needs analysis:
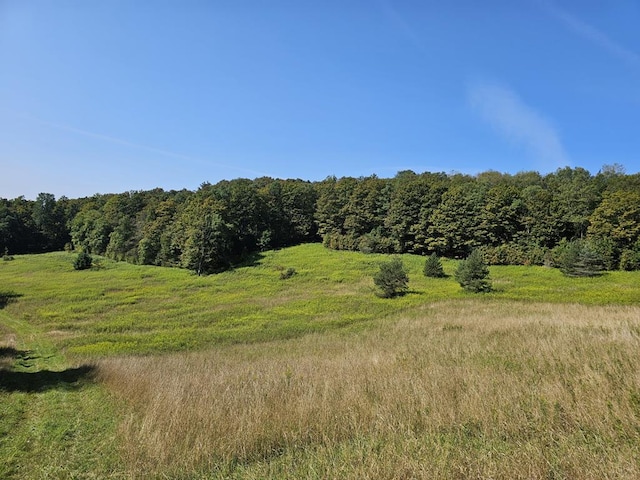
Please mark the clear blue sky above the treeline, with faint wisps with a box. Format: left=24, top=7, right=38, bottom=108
left=0, top=0, right=640, bottom=198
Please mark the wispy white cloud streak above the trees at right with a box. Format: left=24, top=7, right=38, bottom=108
left=468, top=83, right=571, bottom=170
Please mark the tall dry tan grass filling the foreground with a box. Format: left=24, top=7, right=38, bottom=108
left=99, top=301, right=640, bottom=479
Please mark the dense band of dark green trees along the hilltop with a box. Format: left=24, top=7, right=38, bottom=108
left=0, top=165, right=640, bottom=274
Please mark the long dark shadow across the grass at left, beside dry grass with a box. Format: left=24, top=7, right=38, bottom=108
left=0, top=365, right=95, bottom=392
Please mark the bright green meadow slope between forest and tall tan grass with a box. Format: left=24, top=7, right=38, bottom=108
left=0, top=244, right=640, bottom=357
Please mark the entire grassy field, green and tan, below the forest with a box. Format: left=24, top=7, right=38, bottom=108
left=0, top=245, right=640, bottom=479
